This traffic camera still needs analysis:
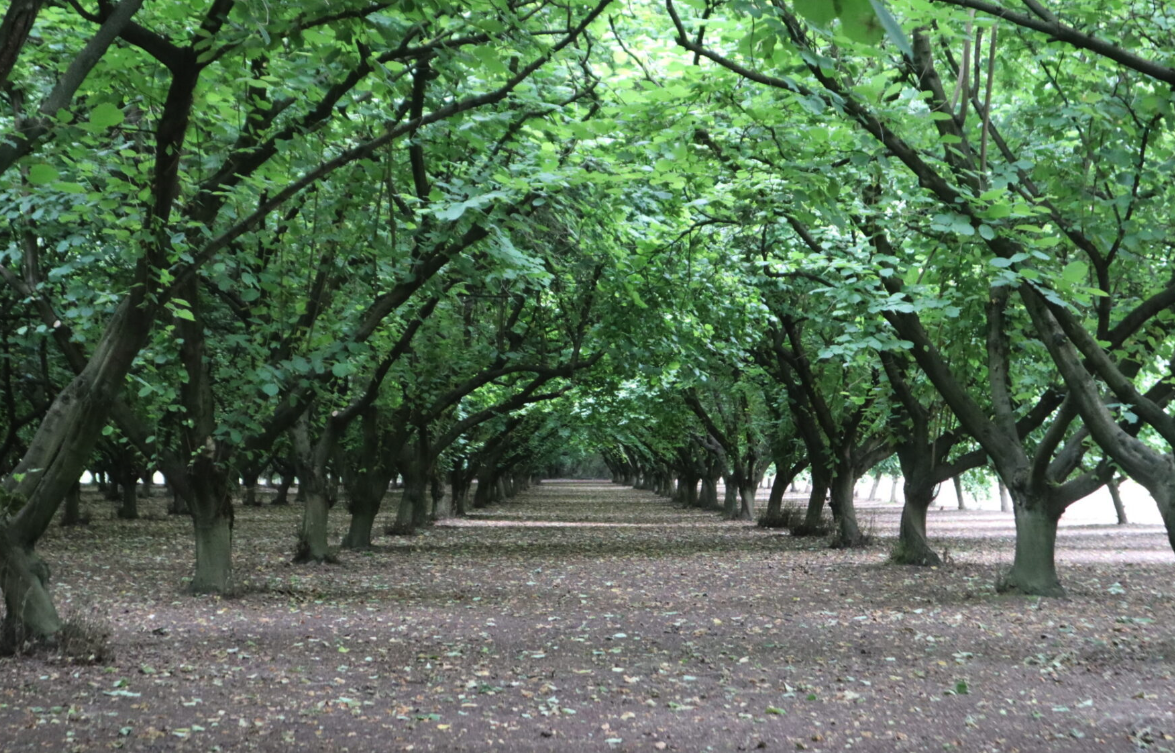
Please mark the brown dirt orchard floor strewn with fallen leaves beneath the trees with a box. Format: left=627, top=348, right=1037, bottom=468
left=0, top=482, right=1175, bottom=753
